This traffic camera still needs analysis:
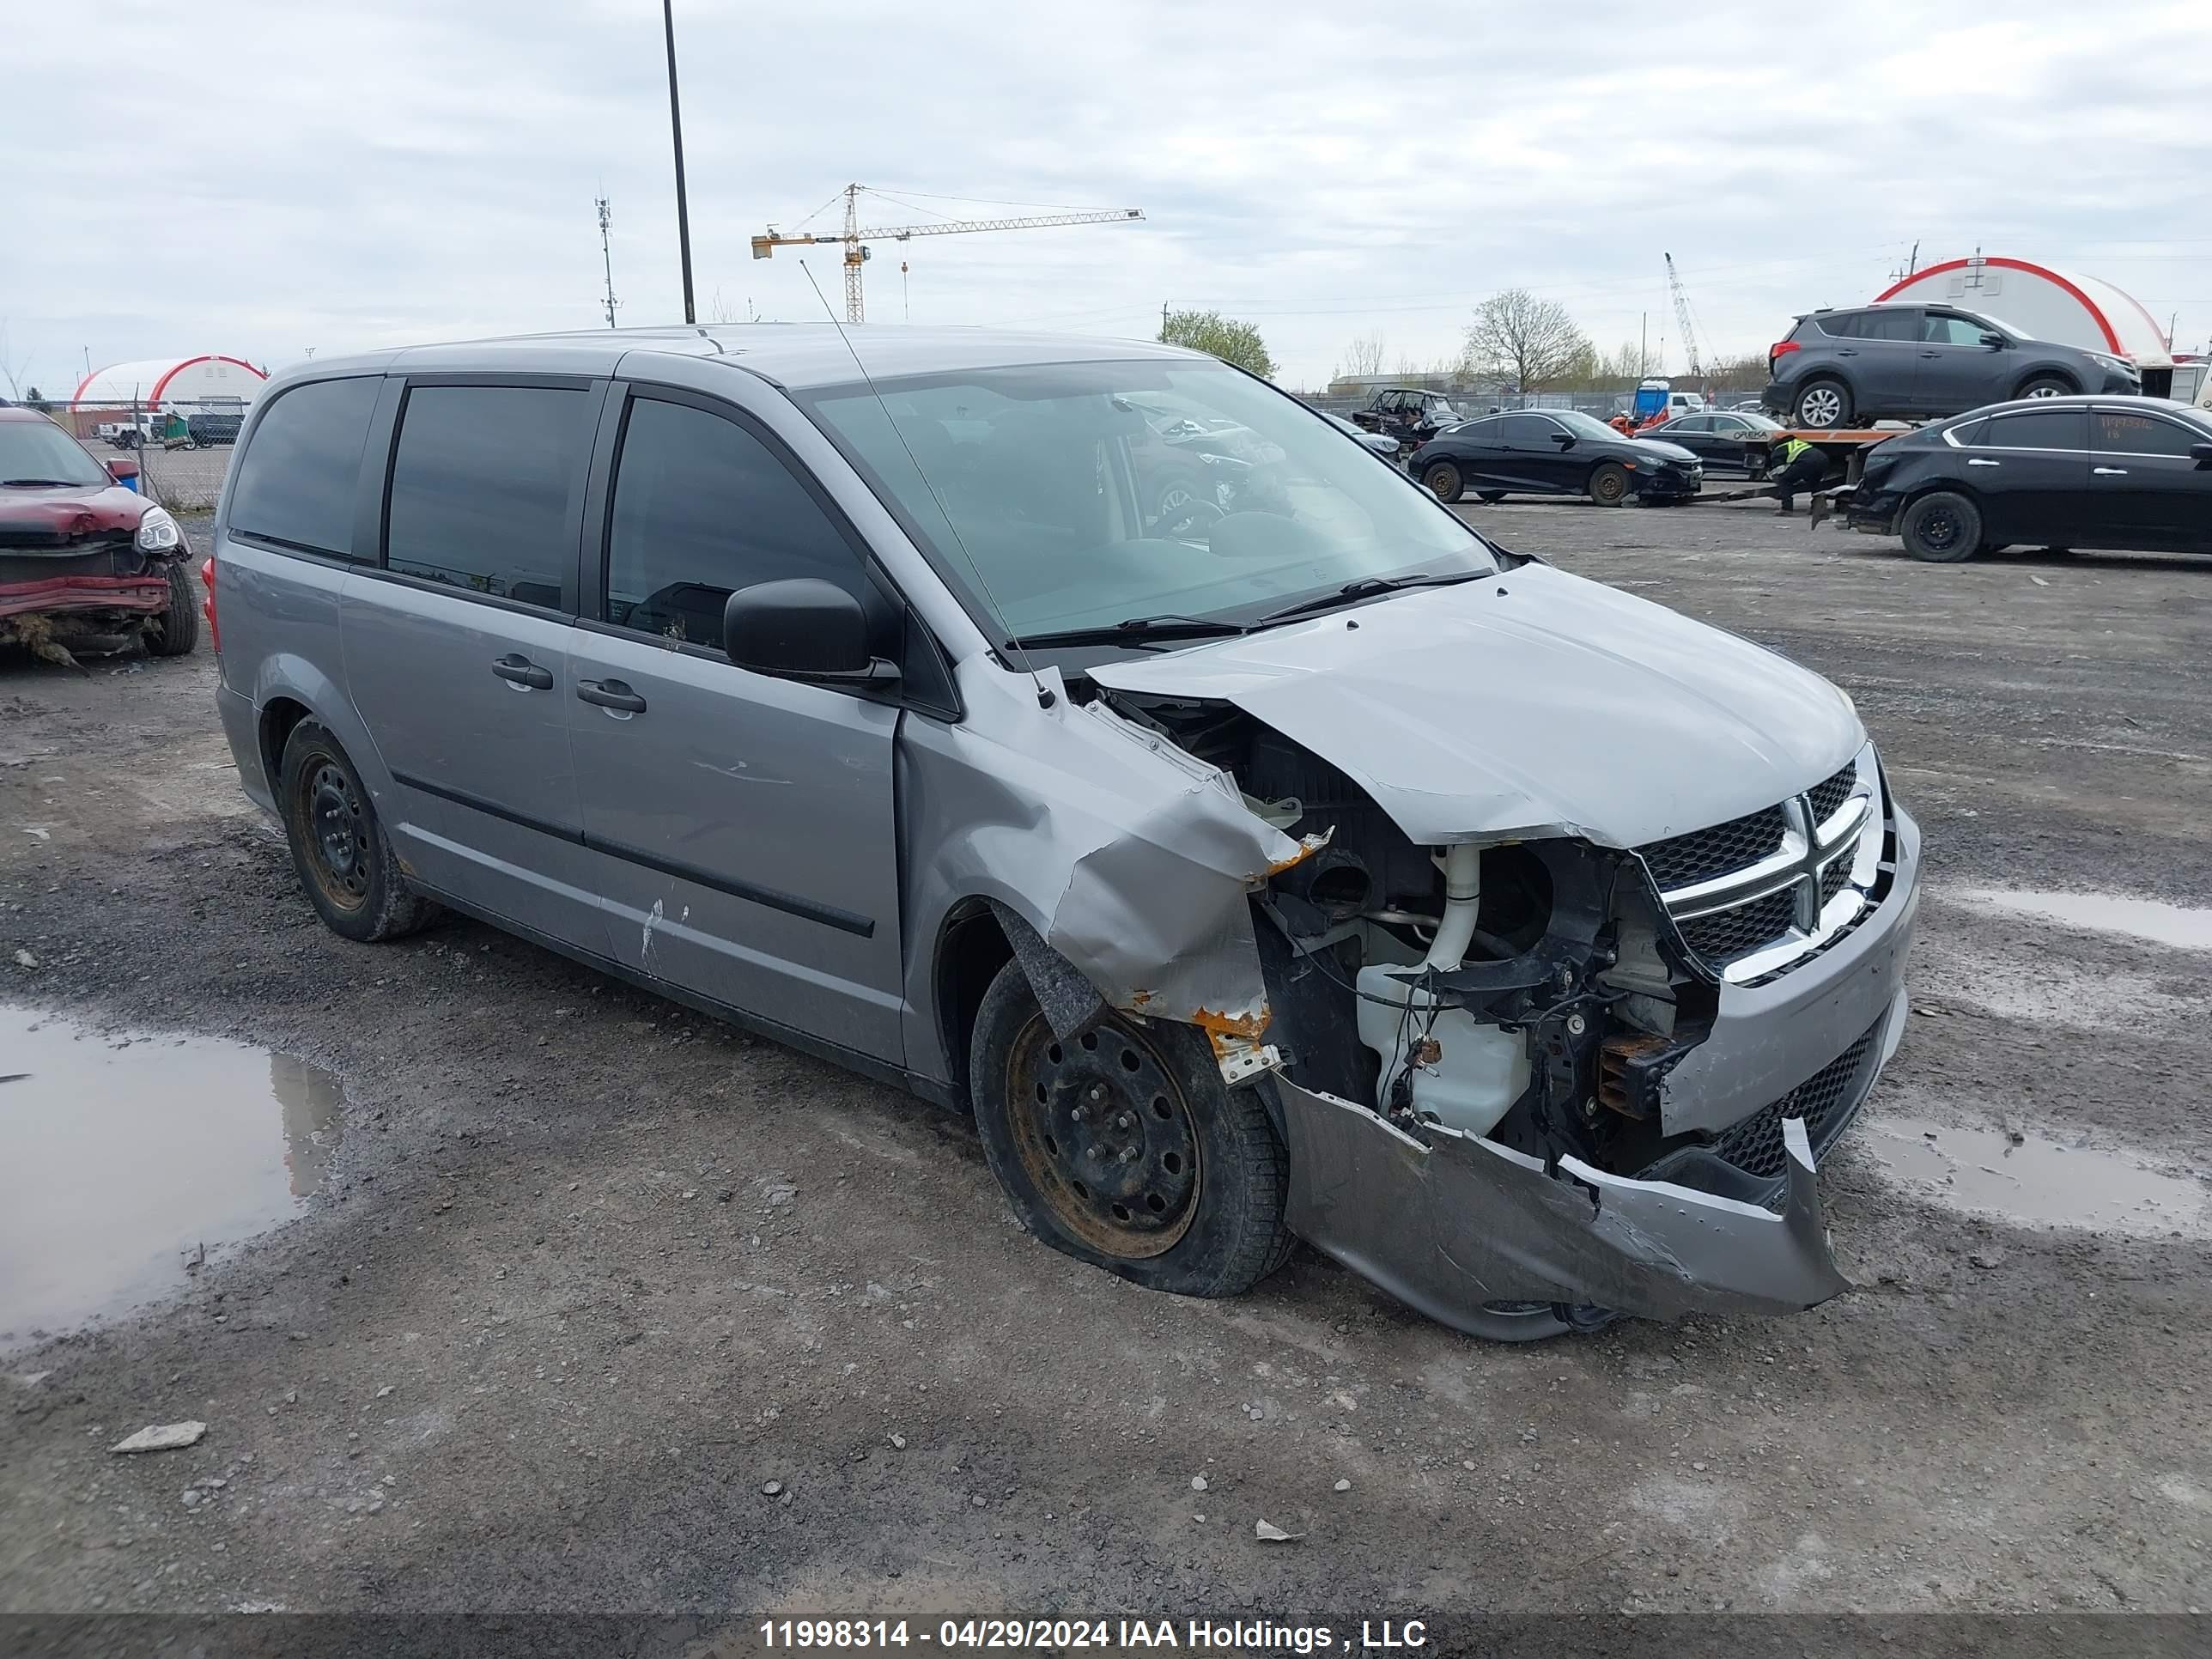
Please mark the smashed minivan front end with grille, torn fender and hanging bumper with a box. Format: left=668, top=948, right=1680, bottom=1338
left=951, top=636, right=1917, bottom=1338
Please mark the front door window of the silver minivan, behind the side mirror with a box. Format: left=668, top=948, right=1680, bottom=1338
left=606, top=398, right=863, bottom=650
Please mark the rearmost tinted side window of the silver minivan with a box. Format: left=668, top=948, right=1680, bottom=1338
left=230, top=376, right=385, bottom=557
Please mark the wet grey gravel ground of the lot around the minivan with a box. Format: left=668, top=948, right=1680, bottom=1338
left=0, top=504, right=2212, bottom=1628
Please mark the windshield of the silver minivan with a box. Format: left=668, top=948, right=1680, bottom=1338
left=801, top=361, right=1495, bottom=639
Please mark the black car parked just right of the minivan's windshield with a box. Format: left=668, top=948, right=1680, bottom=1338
left=1407, top=410, right=1705, bottom=507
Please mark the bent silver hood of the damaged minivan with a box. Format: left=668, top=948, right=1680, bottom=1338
left=1091, top=564, right=1867, bottom=848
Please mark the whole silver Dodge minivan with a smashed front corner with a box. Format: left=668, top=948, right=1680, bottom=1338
left=208, top=325, right=1920, bottom=1338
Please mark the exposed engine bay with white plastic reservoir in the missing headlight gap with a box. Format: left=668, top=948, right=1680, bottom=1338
left=1110, top=692, right=1719, bottom=1175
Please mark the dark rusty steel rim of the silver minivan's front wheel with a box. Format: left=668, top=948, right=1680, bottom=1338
left=1006, top=1013, right=1203, bottom=1261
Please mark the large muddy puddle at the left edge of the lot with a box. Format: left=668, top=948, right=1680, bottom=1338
left=0, top=1006, right=341, bottom=1345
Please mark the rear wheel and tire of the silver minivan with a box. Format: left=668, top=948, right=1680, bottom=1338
left=276, top=721, right=438, bottom=945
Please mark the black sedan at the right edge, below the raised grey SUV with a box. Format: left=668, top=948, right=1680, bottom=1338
left=1836, top=398, right=2212, bottom=564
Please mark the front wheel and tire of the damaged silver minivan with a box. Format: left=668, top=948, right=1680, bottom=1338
left=969, top=963, right=1291, bottom=1297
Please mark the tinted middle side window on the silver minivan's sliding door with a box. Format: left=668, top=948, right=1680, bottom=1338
left=385, top=385, right=592, bottom=608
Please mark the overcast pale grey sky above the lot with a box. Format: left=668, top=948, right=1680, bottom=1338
left=0, top=0, right=2212, bottom=394
